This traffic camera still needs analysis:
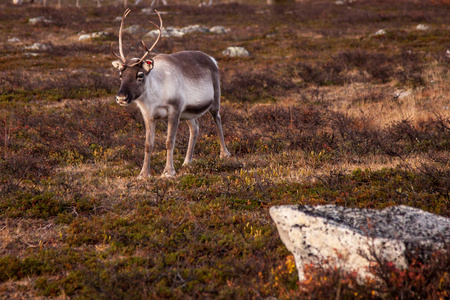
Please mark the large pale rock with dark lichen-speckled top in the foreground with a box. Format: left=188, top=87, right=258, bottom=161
left=270, top=205, right=450, bottom=280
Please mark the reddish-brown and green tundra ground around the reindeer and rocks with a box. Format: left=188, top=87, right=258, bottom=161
left=0, top=0, right=450, bottom=299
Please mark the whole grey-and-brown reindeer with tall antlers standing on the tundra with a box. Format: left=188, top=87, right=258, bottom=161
left=111, top=9, right=230, bottom=178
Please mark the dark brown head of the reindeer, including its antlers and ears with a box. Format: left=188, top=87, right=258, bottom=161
left=111, top=9, right=162, bottom=106
